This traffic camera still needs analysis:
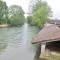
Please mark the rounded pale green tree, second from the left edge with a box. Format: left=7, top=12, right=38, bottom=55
left=9, top=5, right=25, bottom=26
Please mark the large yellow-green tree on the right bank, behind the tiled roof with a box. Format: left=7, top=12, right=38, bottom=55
left=27, top=0, right=52, bottom=28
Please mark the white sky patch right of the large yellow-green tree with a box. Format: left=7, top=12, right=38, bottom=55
left=46, top=0, right=60, bottom=19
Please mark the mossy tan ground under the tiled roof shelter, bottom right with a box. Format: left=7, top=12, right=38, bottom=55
left=40, top=50, right=60, bottom=60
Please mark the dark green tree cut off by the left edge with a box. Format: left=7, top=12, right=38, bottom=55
left=0, top=0, right=8, bottom=24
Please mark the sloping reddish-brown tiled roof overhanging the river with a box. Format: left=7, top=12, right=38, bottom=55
left=32, top=25, right=60, bottom=43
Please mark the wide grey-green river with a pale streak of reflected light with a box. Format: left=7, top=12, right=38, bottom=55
left=0, top=23, right=40, bottom=60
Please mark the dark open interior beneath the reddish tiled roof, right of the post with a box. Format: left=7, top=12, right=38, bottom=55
left=46, top=41, right=60, bottom=52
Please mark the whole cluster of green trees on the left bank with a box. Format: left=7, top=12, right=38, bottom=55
left=0, top=0, right=25, bottom=26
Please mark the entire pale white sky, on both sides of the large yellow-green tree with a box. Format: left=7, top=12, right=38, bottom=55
left=4, top=0, right=60, bottom=19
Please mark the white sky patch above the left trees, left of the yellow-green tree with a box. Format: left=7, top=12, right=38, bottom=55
left=3, top=0, right=30, bottom=16
